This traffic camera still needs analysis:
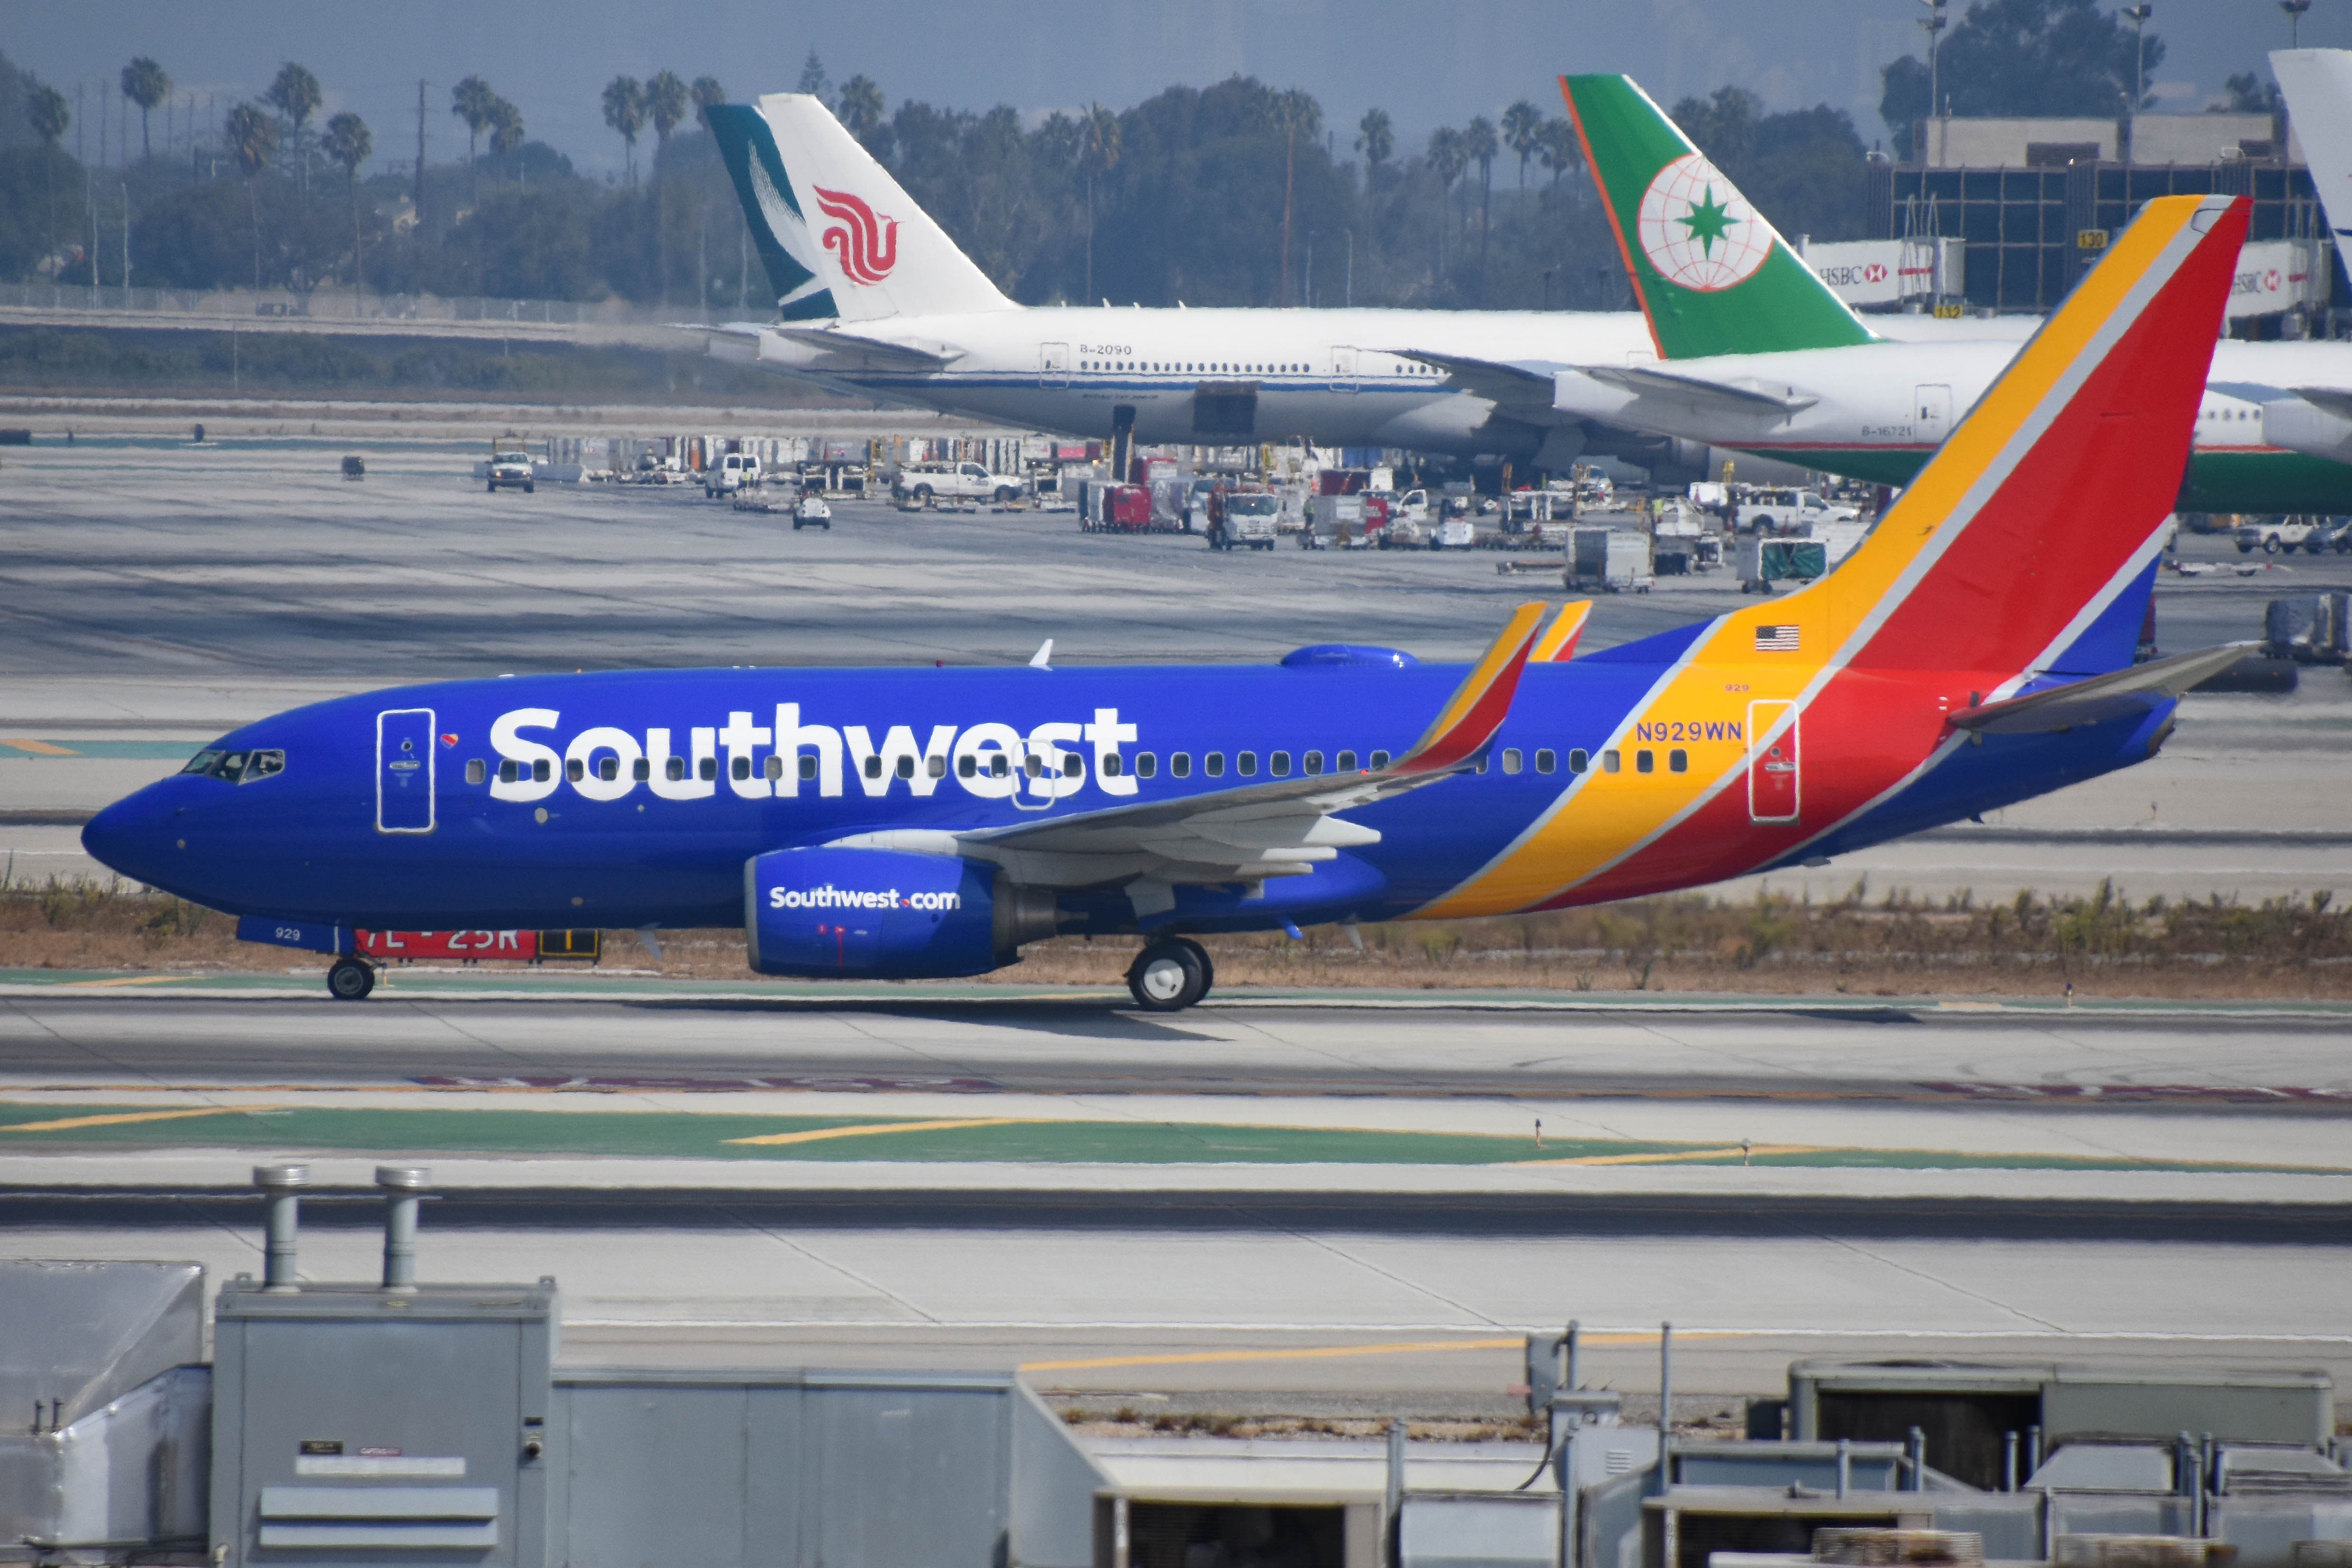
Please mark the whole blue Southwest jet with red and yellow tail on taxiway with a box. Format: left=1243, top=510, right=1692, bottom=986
left=83, top=197, right=2246, bottom=1008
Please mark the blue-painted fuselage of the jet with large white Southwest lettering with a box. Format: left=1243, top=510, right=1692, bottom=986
left=85, top=658, right=2171, bottom=931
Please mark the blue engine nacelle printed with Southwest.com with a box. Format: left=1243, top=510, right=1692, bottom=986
left=743, top=849, right=1056, bottom=980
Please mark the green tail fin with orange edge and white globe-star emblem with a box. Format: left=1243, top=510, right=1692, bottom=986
left=1559, top=75, right=1874, bottom=360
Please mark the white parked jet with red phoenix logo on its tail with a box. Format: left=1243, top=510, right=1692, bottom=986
left=710, top=92, right=1985, bottom=477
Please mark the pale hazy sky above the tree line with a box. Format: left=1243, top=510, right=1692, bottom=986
left=18, top=0, right=2352, bottom=172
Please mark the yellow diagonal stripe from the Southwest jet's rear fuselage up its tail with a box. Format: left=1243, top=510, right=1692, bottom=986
left=1420, top=197, right=2199, bottom=919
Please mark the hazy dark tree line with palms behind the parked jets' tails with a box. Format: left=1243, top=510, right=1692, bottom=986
left=0, top=0, right=2164, bottom=315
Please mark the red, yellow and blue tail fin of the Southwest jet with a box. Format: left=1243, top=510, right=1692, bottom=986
left=1769, top=195, right=2249, bottom=686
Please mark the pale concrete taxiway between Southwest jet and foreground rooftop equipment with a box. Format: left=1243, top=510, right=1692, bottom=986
left=0, top=983, right=2352, bottom=1408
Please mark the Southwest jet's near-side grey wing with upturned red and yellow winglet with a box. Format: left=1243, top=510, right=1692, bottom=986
left=837, top=604, right=1543, bottom=893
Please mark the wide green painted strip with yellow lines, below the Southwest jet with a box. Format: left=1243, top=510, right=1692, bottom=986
left=0, top=1103, right=2345, bottom=1175
